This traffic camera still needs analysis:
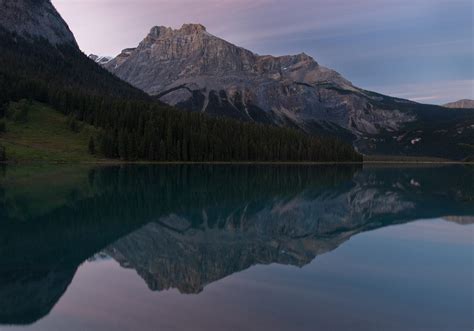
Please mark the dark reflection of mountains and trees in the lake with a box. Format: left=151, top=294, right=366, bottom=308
left=0, top=165, right=474, bottom=325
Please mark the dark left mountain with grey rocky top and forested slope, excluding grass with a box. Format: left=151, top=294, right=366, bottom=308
left=0, top=0, right=362, bottom=162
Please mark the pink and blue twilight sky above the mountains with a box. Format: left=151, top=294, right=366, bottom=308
left=52, top=0, right=474, bottom=104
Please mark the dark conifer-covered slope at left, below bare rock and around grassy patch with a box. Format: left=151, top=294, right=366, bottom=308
left=0, top=30, right=361, bottom=161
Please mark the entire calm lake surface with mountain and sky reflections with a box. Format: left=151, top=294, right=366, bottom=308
left=0, top=166, right=474, bottom=331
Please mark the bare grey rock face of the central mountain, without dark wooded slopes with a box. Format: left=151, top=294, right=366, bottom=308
left=104, top=24, right=415, bottom=136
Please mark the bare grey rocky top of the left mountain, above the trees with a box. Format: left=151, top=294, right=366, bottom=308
left=0, top=0, right=77, bottom=47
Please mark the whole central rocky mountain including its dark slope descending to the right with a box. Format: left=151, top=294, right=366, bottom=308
left=104, top=24, right=474, bottom=158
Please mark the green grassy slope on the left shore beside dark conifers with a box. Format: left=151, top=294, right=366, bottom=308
left=0, top=101, right=98, bottom=162
